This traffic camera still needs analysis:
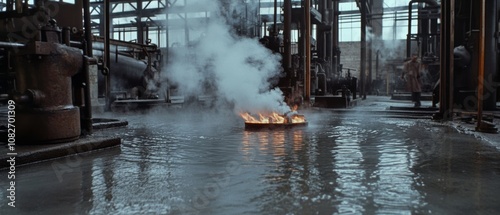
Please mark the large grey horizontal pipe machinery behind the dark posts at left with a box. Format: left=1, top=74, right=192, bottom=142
left=92, top=36, right=163, bottom=102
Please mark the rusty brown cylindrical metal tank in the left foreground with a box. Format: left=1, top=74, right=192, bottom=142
left=12, top=20, right=83, bottom=144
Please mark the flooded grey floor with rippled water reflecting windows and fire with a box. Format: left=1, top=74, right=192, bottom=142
left=0, top=111, right=500, bottom=214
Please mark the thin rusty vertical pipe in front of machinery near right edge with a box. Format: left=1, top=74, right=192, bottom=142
left=476, top=0, right=486, bottom=127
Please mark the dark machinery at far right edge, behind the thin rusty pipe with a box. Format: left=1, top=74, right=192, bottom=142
left=450, top=0, right=500, bottom=111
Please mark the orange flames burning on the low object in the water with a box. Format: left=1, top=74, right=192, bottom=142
left=240, top=112, right=306, bottom=124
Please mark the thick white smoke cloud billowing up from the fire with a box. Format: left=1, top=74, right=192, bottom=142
left=164, top=0, right=290, bottom=113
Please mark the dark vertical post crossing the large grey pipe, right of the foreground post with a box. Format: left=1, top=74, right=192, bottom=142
left=104, top=0, right=111, bottom=111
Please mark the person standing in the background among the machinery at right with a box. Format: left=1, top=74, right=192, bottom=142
left=402, top=54, right=422, bottom=107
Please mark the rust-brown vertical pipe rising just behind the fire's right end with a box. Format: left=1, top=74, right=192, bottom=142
left=304, top=0, right=311, bottom=102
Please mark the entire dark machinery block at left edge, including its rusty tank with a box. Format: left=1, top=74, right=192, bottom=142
left=0, top=1, right=96, bottom=144
